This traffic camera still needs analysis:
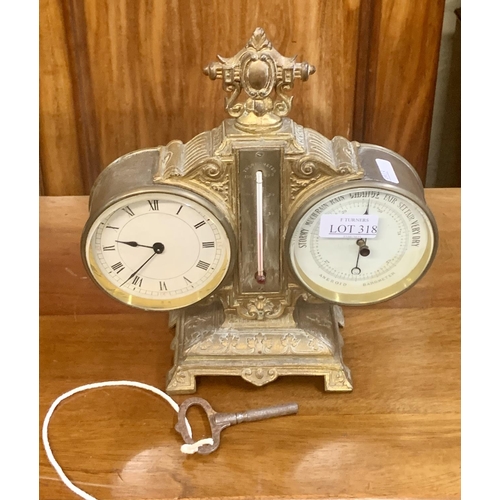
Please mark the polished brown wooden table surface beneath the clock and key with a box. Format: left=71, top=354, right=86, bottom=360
left=39, top=189, right=461, bottom=500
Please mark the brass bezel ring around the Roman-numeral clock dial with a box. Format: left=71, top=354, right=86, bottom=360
left=80, top=185, right=236, bottom=312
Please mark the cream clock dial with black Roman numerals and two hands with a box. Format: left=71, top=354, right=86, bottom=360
left=85, top=192, right=231, bottom=310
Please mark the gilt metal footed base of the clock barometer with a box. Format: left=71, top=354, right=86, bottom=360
left=167, top=300, right=352, bottom=394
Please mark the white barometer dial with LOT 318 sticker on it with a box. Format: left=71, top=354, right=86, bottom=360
left=289, top=187, right=437, bottom=305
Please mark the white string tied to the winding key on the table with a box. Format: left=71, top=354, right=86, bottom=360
left=42, top=380, right=214, bottom=500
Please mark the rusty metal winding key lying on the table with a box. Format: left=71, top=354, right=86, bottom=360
left=175, top=397, right=299, bottom=455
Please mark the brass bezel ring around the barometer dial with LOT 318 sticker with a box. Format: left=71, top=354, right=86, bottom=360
left=285, top=178, right=439, bottom=307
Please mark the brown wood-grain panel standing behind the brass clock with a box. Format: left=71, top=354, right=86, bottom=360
left=39, top=0, right=444, bottom=195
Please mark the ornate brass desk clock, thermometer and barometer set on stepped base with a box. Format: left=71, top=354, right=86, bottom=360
left=81, top=28, right=438, bottom=393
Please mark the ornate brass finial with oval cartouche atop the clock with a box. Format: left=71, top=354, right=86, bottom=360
left=204, top=28, right=316, bottom=132
